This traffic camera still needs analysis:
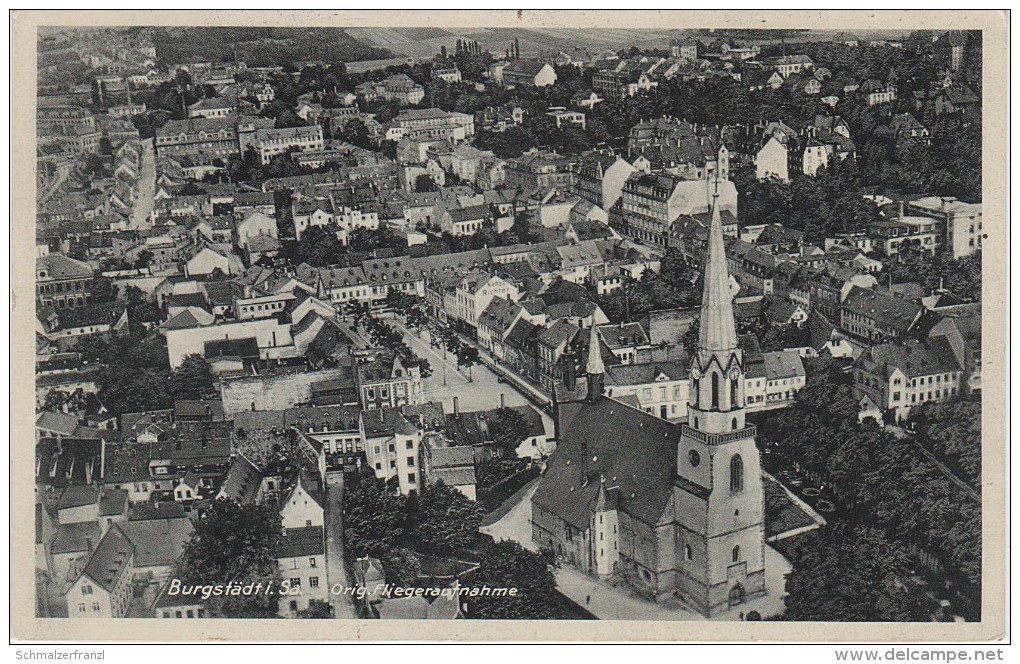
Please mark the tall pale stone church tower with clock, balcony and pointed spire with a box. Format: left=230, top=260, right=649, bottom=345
left=674, top=183, right=765, bottom=616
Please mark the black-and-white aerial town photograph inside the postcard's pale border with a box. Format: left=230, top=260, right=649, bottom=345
left=31, top=18, right=987, bottom=625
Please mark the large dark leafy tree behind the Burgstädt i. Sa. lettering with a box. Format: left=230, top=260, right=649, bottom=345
left=179, top=500, right=283, bottom=618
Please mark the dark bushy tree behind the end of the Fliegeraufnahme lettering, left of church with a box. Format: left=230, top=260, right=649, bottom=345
left=465, top=540, right=562, bottom=619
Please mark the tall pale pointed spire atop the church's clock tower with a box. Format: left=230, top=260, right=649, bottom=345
left=698, top=174, right=736, bottom=353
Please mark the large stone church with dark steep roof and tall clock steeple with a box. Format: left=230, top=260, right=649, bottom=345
left=531, top=183, right=766, bottom=616
